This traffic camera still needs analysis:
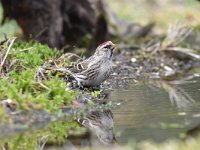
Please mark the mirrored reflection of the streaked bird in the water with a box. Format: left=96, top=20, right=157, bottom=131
left=78, top=110, right=116, bottom=145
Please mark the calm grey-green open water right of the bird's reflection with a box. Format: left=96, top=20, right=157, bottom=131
left=110, top=77, right=200, bottom=144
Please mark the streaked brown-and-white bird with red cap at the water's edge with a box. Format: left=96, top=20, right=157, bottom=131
left=68, top=41, right=116, bottom=88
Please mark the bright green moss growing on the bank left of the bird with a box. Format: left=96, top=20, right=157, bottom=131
left=0, top=41, right=74, bottom=111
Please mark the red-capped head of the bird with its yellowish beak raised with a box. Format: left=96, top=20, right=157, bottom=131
left=95, top=41, right=116, bottom=59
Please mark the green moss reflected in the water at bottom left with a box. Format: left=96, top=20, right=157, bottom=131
left=0, top=121, right=77, bottom=150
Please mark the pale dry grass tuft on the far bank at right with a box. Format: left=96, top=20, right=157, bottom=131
left=143, top=23, right=200, bottom=60
